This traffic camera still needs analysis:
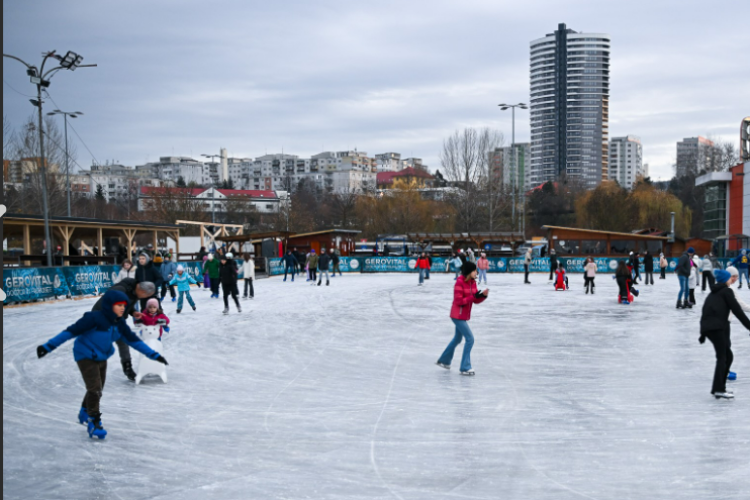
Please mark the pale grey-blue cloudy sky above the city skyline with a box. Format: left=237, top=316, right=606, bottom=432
left=3, top=0, right=750, bottom=178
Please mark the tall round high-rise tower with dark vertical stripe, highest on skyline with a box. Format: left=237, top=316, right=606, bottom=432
left=527, top=24, right=610, bottom=188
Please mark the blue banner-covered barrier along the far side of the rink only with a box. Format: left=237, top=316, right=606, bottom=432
left=268, top=256, right=731, bottom=276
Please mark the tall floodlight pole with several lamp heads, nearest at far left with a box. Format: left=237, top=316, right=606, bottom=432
left=3, top=50, right=96, bottom=267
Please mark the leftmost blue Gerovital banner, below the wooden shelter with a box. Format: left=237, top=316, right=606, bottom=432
left=3, top=267, right=70, bottom=302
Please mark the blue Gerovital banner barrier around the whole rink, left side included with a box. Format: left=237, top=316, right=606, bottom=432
left=3, top=257, right=730, bottom=303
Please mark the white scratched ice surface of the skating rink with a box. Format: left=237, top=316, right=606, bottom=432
left=3, top=274, right=750, bottom=500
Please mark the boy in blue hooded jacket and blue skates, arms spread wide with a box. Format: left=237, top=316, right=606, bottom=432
left=36, top=290, right=168, bottom=439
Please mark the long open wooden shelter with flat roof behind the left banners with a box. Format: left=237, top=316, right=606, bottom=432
left=3, top=214, right=180, bottom=267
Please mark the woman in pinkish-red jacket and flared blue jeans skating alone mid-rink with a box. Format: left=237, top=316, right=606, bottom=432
left=437, top=262, right=490, bottom=376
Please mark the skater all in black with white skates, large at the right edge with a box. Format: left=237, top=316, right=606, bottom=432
left=699, top=269, right=750, bottom=399
